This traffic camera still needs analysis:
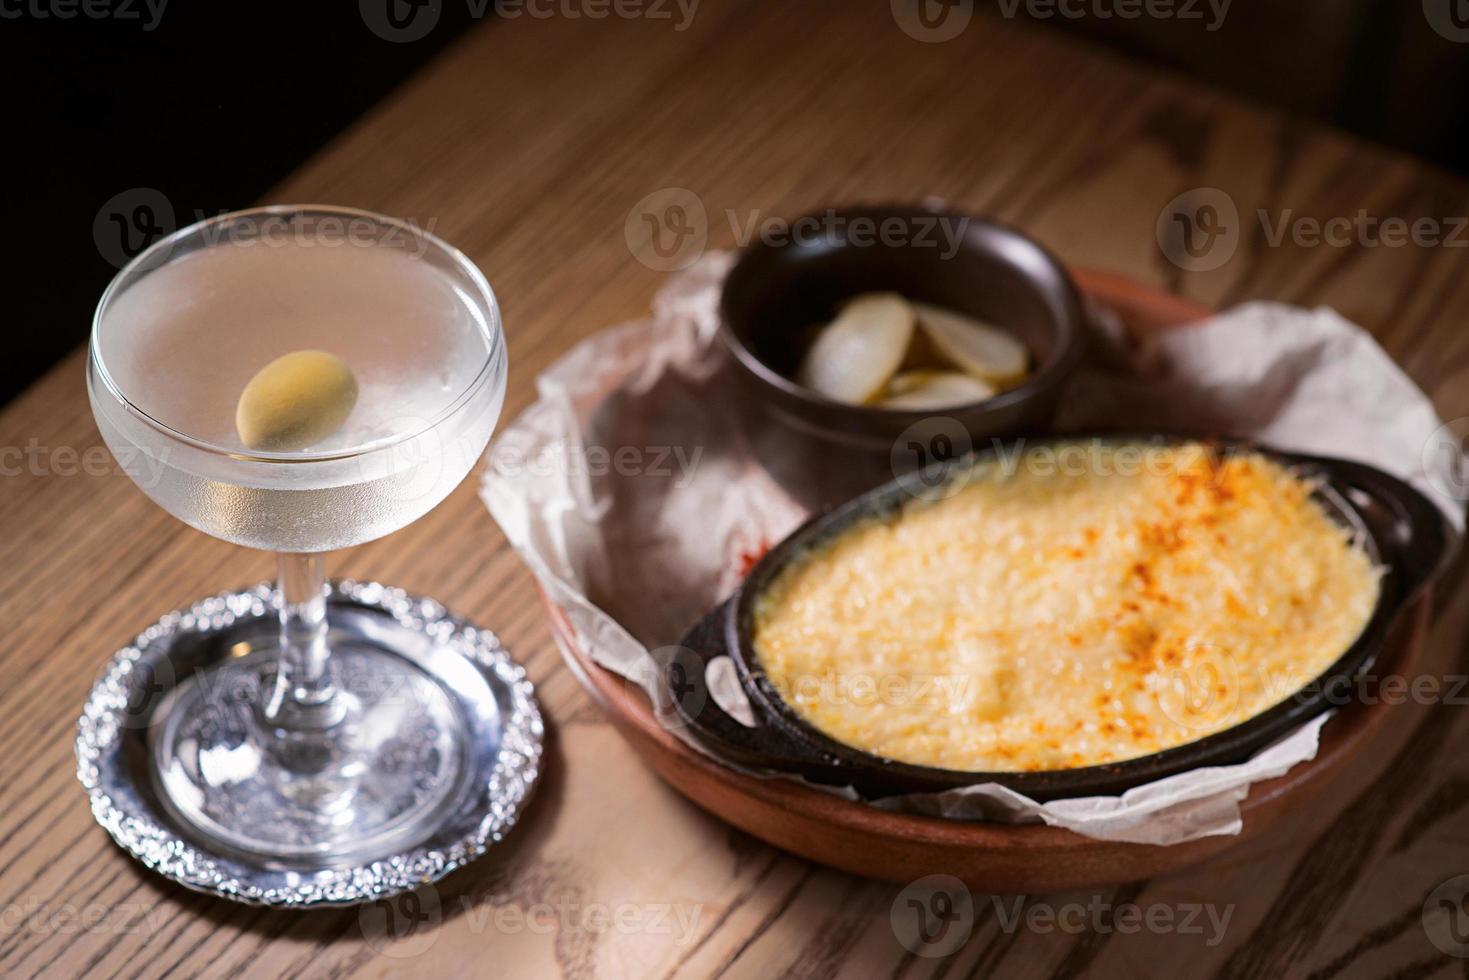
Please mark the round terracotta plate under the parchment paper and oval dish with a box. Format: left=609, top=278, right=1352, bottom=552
left=534, top=270, right=1428, bottom=893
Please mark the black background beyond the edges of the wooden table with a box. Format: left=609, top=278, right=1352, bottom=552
left=0, top=0, right=1469, bottom=403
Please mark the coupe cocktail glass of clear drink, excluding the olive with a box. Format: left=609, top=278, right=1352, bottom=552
left=87, top=206, right=505, bottom=867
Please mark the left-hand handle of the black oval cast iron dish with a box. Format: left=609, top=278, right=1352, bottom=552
left=658, top=598, right=845, bottom=782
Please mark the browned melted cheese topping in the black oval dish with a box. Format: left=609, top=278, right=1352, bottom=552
left=754, top=442, right=1378, bottom=771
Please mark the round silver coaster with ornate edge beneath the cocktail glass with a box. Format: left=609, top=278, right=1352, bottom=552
left=76, top=582, right=544, bottom=908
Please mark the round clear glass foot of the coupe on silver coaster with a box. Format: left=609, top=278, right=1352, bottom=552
left=151, top=645, right=469, bottom=865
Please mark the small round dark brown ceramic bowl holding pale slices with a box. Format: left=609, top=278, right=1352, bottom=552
left=720, top=206, right=1086, bottom=463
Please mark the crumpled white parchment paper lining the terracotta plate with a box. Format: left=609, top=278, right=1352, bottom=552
left=482, top=254, right=1465, bottom=845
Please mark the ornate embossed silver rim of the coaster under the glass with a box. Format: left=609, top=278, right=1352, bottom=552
left=76, top=580, right=545, bottom=909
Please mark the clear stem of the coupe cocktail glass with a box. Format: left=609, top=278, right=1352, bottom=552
left=264, top=551, right=344, bottom=730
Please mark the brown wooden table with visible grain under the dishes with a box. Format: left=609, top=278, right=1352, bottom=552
left=0, top=0, right=1469, bottom=977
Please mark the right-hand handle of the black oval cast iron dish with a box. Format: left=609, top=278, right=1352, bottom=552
left=1321, top=458, right=1454, bottom=605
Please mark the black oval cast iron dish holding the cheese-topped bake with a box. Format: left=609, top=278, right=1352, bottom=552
left=663, top=433, right=1450, bottom=801
